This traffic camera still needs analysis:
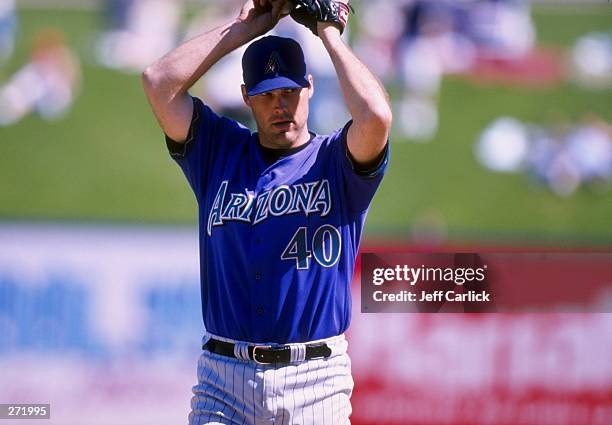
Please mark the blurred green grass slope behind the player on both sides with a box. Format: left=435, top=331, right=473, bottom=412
left=0, top=5, right=612, bottom=245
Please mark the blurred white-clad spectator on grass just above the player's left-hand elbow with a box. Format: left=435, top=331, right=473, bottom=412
left=96, top=0, right=183, bottom=72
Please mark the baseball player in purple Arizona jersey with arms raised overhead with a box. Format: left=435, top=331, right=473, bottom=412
left=143, top=0, right=391, bottom=425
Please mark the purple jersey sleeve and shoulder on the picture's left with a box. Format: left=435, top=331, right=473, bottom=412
left=166, top=97, right=248, bottom=200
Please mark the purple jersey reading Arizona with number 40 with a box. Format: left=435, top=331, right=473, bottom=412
left=168, top=99, right=389, bottom=343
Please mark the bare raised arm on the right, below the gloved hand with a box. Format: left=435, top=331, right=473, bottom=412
left=317, top=18, right=392, bottom=168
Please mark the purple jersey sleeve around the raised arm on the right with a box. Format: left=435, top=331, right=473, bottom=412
left=333, top=121, right=390, bottom=213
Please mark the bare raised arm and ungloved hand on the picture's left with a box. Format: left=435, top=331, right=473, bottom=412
left=142, top=0, right=286, bottom=142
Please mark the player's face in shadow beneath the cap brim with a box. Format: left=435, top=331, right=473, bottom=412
left=245, top=81, right=313, bottom=148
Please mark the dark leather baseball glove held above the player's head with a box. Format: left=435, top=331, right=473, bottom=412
left=289, top=0, right=354, bottom=35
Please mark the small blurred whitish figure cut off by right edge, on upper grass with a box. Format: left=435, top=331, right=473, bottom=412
left=571, top=33, right=612, bottom=89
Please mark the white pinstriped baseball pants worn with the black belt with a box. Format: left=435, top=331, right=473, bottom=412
left=189, top=335, right=353, bottom=425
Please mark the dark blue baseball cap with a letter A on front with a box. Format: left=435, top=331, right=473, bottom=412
left=242, top=35, right=310, bottom=96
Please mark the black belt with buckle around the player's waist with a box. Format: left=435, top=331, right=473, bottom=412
left=202, top=338, right=331, bottom=364
